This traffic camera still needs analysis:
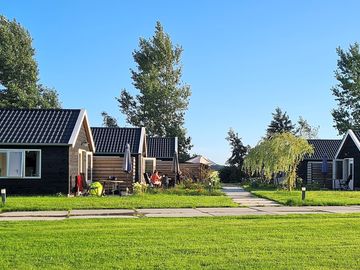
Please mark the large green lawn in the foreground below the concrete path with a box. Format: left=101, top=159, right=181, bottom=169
left=0, top=214, right=360, bottom=270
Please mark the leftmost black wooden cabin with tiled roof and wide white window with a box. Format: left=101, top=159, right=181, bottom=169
left=0, top=109, right=95, bottom=194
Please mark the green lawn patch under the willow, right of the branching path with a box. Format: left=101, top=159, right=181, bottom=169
left=251, top=190, right=360, bottom=206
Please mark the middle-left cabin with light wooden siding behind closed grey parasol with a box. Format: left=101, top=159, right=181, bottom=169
left=91, top=127, right=147, bottom=190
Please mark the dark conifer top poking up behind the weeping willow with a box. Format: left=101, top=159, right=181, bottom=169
left=266, top=107, right=295, bottom=138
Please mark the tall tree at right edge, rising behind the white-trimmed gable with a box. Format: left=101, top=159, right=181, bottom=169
left=331, top=43, right=360, bottom=135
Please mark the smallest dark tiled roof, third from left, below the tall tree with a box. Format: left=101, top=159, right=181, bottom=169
left=147, top=137, right=177, bottom=158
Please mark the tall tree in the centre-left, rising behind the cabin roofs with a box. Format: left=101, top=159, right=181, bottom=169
left=117, top=22, right=192, bottom=160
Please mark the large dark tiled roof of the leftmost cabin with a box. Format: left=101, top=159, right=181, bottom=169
left=0, top=109, right=80, bottom=144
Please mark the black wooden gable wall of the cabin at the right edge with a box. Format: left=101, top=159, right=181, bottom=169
left=337, top=136, right=360, bottom=189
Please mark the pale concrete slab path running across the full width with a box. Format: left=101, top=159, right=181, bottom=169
left=0, top=205, right=360, bottom=222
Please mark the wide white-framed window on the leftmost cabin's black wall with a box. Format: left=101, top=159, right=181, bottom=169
left=0, top=149, right=41, bottom=179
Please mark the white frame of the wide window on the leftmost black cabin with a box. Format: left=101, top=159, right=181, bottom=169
left=0, top=148, right=42, bottom=179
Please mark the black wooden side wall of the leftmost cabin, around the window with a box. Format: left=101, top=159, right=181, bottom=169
left=0, top=146, right=69, bottom=195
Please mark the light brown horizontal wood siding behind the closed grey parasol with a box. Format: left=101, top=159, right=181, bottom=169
left=93, top=156, right=136, bottom=190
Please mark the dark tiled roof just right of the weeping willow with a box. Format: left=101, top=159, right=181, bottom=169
left=304, top=139, right=342, bottom=160
